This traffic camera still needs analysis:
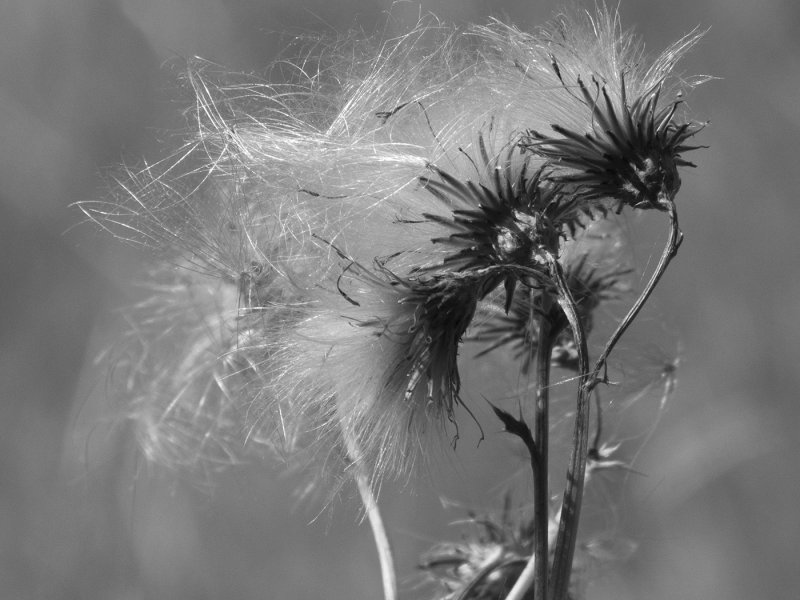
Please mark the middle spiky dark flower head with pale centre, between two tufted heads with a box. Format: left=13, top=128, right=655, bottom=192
left=421, top=127, right=591, bottom=312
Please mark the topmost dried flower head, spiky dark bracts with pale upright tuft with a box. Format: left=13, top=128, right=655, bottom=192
left=480, top=10, right=703, bottom=208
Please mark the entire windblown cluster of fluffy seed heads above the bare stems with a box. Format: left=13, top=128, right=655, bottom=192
left=82, top=10, right=701, bottom=492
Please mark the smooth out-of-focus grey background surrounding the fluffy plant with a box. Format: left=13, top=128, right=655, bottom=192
left=0, top=0, right=800, bottom=600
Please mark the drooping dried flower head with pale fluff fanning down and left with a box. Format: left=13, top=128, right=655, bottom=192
left=267, top=246, right=481, bottom=481
